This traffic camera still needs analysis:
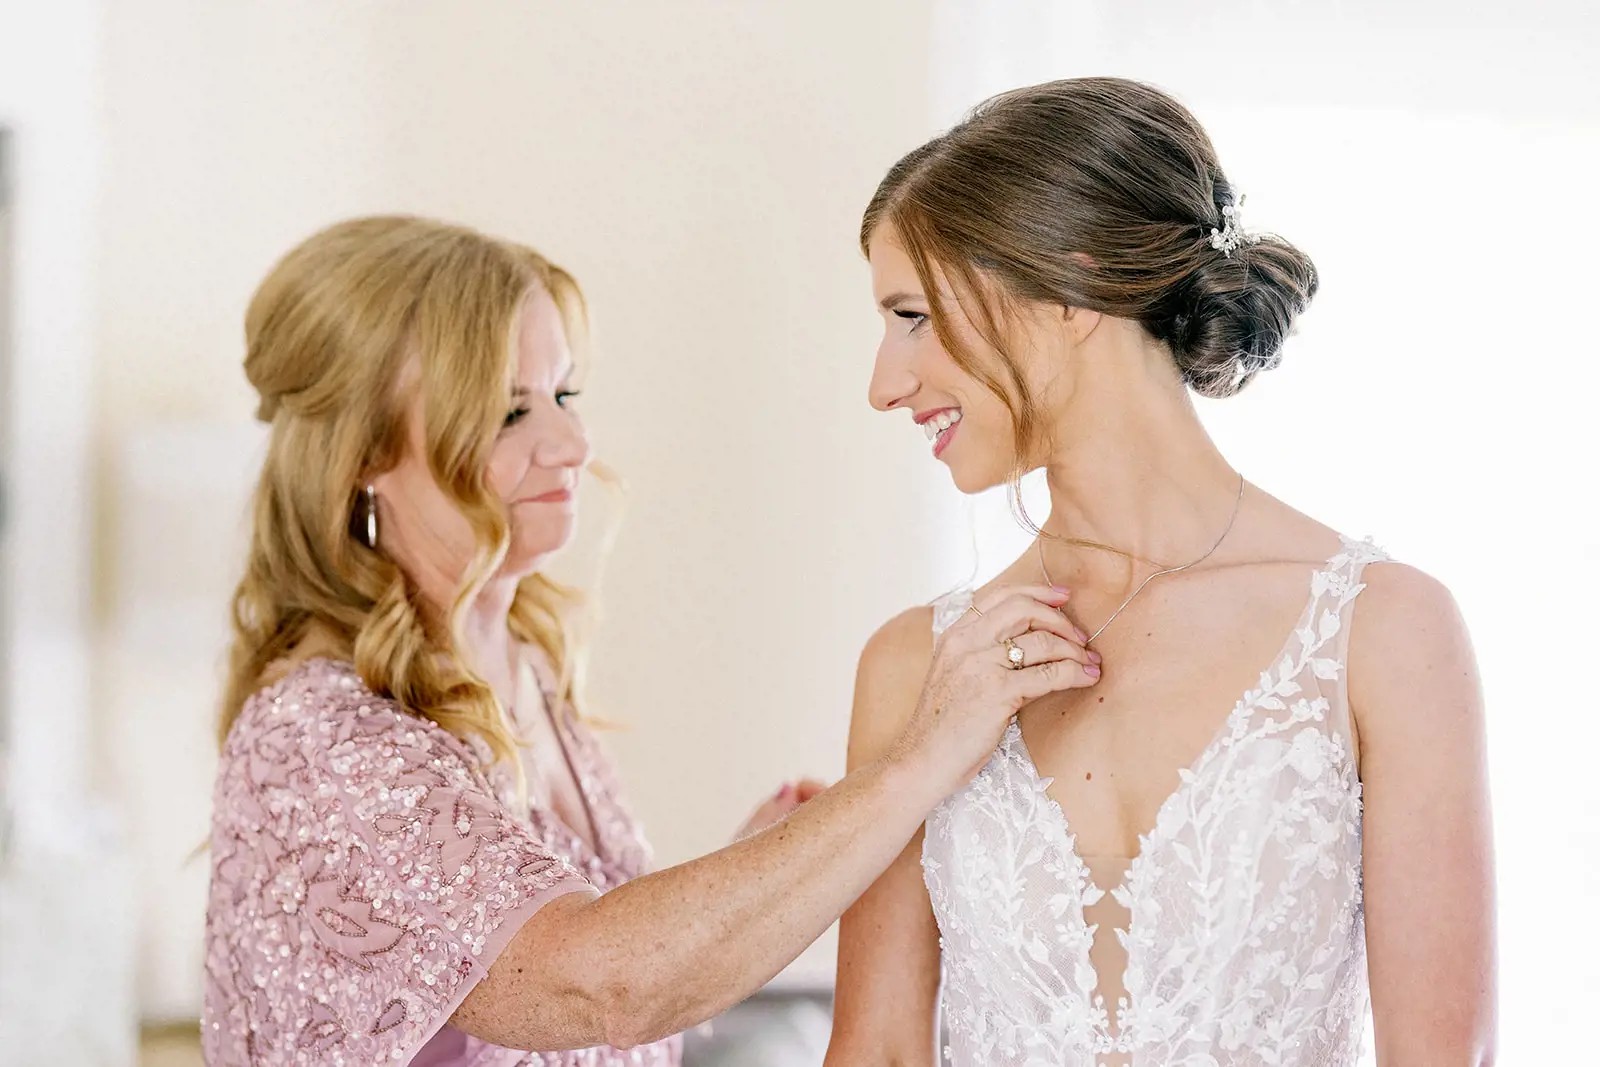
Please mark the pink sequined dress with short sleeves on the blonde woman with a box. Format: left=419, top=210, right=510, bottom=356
left=202, top=659, right=682, bottom=1067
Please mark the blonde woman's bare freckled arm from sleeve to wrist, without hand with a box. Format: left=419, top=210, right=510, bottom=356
left=454, top=739, right=939, bottom=1051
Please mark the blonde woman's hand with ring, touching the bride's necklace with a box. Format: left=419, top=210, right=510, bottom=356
left=891, top=585, right=1101, bottom=790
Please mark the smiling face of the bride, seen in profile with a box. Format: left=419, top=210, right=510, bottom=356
left=867, top=229, right=1050, bottom=493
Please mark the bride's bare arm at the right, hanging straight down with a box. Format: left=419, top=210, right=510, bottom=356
left=1349, top=563, right=1496, bottom=1067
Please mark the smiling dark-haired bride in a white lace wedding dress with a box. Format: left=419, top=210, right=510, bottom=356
left=827, top=78, right=1494, bottom=1067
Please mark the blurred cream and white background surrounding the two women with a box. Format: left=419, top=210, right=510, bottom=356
left=0, top=0, right=1600, bottom=1067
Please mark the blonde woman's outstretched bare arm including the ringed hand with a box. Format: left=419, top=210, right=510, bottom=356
left=453, top=587, right=1093, bottom=1049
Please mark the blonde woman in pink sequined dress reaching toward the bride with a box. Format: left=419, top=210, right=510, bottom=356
left=203, top=218, right=1098, bottom=1065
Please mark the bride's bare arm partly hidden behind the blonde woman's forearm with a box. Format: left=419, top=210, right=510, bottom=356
left=824, top=609, right=939, bottom=1067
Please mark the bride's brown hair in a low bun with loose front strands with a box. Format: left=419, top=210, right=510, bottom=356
left=861, top=78, right=1317, bottom=438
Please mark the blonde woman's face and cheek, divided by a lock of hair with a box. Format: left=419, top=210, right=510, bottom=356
left=373, top=288, right=589, bottom=587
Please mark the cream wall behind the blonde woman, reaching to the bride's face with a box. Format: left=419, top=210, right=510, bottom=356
left=94, top=0, right=965, bottom=1016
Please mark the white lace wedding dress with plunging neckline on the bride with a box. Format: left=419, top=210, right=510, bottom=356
left=922, top=539, right=1386, bottom=1067
